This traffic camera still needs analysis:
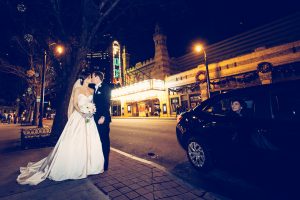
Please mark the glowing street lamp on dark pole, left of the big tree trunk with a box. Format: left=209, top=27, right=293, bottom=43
left=38, top=42, right=65, bottom=128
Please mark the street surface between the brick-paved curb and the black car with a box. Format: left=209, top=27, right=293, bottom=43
left=110, top=119, right=258, bottom=198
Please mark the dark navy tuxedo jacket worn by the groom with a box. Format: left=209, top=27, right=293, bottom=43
left=89, top=83, right=111, bottom=123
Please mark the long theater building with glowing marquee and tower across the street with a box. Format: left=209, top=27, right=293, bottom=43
left=112, top=14, right=300, bottom=117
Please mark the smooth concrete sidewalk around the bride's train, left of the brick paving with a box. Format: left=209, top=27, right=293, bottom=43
left=0, top=145, right=108, bottom=200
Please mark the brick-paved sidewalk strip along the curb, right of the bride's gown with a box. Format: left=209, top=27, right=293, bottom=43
left=89, top=151, right=227, bottom=200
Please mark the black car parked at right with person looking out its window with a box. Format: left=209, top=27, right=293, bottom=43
left=176, top=80, right=300, bottom=170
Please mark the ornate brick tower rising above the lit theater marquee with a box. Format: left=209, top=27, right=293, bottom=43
left=153, top=24, right=170, bottom=80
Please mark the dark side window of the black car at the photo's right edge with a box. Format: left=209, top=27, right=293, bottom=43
left=272, top=93, right=300, bottom=120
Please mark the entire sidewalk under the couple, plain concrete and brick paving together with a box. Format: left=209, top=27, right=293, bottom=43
left=0, top=124, right=226, bottom=200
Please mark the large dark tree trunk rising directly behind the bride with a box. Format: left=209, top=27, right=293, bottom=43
left=43, top=0, right=124, bottom=139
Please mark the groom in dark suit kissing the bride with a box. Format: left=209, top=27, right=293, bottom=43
left=91, top=71, right=111, bottom=171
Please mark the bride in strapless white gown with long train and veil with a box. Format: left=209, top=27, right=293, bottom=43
left=17, top=73, right=104, bottom=185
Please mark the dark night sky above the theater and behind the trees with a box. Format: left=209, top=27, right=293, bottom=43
left=0, top=0, right=299, bottom=103
